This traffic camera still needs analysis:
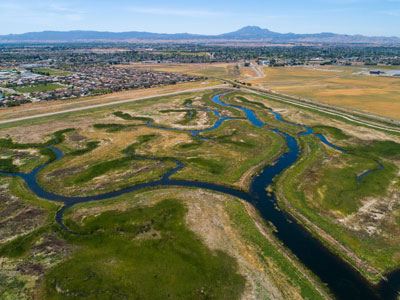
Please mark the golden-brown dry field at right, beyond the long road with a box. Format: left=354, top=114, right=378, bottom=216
left=250, top=66, right=400, bottom=120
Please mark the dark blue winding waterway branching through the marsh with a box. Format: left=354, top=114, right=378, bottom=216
left=0, top=95, right=400, bottom=300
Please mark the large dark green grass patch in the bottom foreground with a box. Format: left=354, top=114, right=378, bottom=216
left=45, top=200, right=245, bottom=300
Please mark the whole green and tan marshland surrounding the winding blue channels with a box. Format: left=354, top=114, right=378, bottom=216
left=0, top=84, right=400, bottom=300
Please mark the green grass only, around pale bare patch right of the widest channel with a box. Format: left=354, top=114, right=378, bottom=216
left=277, top=136, right=400, bottom=280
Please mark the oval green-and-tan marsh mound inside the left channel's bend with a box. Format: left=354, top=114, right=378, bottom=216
left=38, top=134, right=176, bottom=196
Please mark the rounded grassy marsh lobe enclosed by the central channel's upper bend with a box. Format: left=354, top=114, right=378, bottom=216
left=170, top=120, right=283, bottom=189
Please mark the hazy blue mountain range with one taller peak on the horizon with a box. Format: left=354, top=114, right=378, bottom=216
left=0, top=26, right=400, bottom=45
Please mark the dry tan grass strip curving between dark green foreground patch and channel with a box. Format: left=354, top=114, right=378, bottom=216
left=60, top=188, right=322, bottom=299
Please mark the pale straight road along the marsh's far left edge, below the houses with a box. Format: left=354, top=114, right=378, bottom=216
left=0, top=84, right=229, bottom=124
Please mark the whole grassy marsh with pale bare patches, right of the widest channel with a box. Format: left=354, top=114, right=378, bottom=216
left=278, top=134, right=400, bottom=280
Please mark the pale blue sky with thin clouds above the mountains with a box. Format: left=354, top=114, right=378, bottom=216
left=0, top=0, right=400, bottom=37
